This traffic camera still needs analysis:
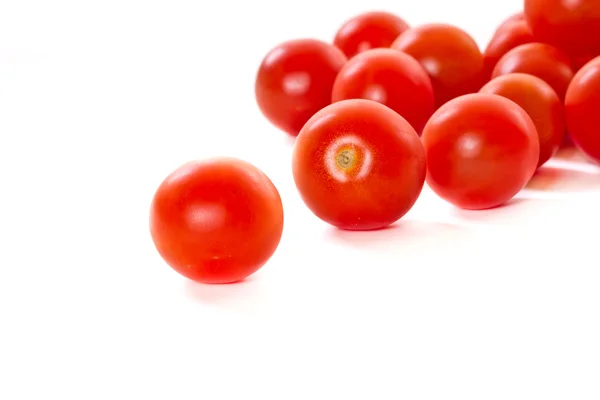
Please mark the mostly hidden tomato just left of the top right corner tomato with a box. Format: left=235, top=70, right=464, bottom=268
left=483, top=19, right=535, bottom=78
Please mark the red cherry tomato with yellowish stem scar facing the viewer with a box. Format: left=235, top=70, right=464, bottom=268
left=293, top=99, right=425, bottom=230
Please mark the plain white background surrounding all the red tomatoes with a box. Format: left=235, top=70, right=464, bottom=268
left=0, top=0, right=600, bottom=400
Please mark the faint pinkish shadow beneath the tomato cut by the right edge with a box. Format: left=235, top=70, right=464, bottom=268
left=526, top=164, right=600, bottom=192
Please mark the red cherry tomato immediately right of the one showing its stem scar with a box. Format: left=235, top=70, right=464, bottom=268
left=422, top=93, right=540, bottom=210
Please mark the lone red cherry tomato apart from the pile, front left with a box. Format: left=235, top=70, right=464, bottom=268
left=150, top=158, right=283, bottom=283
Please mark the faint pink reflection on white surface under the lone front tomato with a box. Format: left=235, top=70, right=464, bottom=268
left=184, top=276, right=266, bottom=313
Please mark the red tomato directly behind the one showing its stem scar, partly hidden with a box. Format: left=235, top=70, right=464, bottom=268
left=332, top=49, right=434, bottom=132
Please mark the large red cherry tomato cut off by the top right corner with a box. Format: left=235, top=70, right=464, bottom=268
left=525, top=0, right=600, bottom=55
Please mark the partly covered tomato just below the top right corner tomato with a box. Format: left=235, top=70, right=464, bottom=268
left=492, top=43, right=573, bottom=100
